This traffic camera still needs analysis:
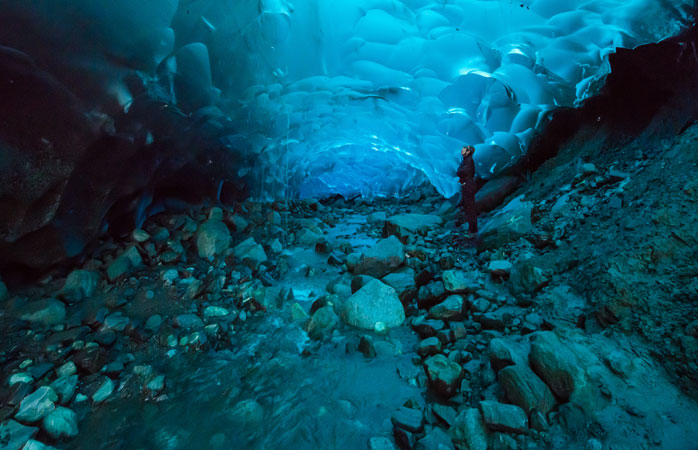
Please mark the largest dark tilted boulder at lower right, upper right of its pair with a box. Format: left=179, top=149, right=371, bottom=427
left=529, top=331, right=588, bottom=402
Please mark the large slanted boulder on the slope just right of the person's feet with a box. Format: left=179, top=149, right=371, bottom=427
left=478, top=196, right=533, bottom=249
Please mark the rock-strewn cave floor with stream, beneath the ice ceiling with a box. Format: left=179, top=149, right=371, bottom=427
left=0, top=124, right=698, bottom=450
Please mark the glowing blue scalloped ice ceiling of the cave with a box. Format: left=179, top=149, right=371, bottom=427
left=0, top=0, right=692, bottom=197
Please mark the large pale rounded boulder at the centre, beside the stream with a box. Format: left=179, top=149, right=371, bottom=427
left=344, top=280, right=405, bottom=330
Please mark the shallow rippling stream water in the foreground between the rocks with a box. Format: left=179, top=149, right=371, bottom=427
left=71, top=314, right=420, bottom=449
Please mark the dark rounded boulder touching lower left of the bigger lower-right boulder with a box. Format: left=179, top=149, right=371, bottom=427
left=498, top=364, right=555, bottom=414
